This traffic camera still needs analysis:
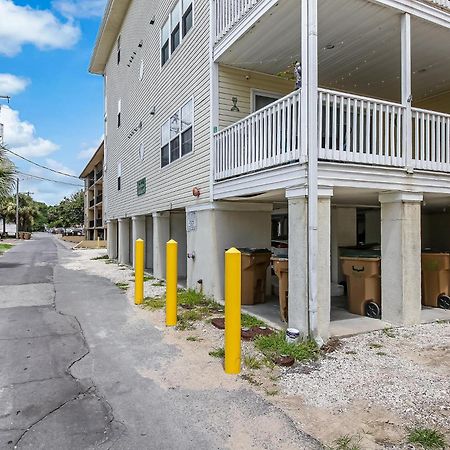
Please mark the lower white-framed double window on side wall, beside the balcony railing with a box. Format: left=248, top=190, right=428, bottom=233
left=161, top=100, right=194, bottom=167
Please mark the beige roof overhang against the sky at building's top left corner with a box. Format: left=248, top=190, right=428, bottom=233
left=89, top=0, right=131, bottom=75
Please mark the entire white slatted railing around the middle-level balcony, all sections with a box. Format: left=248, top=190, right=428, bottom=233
left=214, top=89, right=450, bottom=181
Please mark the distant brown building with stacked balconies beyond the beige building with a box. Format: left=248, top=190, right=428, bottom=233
left=80, top=142, right=106, bottom=241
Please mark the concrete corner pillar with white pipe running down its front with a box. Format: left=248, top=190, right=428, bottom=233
left=286, top=187, right=333, bottom=341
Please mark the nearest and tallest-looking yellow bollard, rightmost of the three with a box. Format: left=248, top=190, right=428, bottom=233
left=225, top=248, right=241, bottom=374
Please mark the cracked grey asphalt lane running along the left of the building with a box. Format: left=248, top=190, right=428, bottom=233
left=0, top=234, right=321, bottom=450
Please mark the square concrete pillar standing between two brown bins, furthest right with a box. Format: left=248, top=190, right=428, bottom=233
left=379, top=192, right=423, bottom=325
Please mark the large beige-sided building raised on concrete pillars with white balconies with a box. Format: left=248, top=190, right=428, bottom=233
left=90, top=0, right=450, bottom=339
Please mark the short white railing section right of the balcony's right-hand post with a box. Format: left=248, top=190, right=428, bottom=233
left=412, top=108, right=450, bottom=172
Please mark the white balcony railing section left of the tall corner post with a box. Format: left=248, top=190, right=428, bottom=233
left=214, top=91, right=301, bottom=181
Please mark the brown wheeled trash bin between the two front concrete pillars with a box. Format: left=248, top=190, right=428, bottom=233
left=341, top=257, right=381, bottom=319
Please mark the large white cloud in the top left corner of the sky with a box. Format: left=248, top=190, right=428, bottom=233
left=0, top=0, right=81, bottom=56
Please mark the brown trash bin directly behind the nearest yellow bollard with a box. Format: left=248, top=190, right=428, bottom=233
left=238, top=248, right=272, bottom=305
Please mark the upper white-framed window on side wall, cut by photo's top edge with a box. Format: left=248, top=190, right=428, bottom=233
left=161, top=0, right=193, bottom=66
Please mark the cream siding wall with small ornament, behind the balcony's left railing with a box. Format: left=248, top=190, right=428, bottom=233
left=219, top=66, right=295, bottom=129
